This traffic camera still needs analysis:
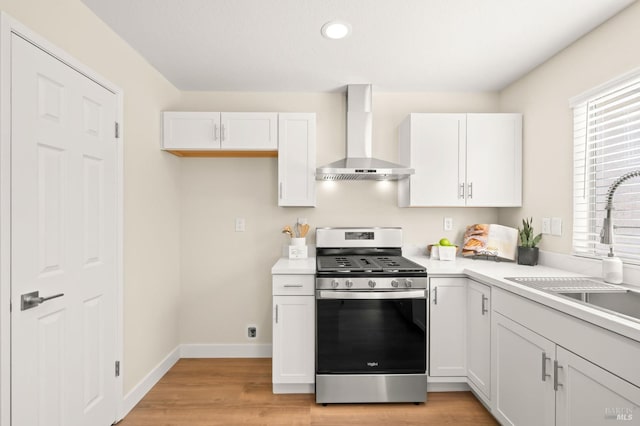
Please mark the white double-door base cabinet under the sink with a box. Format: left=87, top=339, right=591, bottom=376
left=492, top=290, right=640, bottom=426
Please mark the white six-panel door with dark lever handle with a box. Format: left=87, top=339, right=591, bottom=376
left=11, top=35, right=118, bottom=426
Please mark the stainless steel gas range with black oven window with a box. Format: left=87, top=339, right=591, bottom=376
left=316, top=228, right=429, bottom=404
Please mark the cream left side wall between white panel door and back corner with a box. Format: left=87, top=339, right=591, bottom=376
left=0, top=0, right=180, bottom=393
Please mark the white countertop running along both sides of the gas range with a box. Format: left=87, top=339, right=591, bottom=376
left=271, top=256, right=640, bottom=342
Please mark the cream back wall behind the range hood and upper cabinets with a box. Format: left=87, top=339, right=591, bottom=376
left=172, top=87, right=498, bottom=344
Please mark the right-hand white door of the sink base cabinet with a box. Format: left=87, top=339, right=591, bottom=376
left=556, top=346, right=640, bottom=426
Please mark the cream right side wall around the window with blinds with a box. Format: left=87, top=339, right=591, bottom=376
left=499, top=2, right=640, bottom=254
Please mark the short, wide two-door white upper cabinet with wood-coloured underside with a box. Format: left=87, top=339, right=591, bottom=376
left=162, top=112, right=278, bottom=152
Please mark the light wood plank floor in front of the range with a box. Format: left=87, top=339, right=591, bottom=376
left=118, top=358, right=498, bottom=426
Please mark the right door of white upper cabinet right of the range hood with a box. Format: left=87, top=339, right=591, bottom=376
left=466, top=114, right=522, bottom=207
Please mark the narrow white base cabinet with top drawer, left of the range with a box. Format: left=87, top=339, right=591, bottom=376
left=272, top=275, right=315, bottom=393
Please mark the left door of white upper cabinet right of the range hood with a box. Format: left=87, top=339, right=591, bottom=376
left=398, top=114, right=466, bottom=207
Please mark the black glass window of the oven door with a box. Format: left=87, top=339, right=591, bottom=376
left=316, top=299, right=427, bottom=374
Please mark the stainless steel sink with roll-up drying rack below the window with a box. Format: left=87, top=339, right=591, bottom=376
left=505, top=277, right=640, bottom=322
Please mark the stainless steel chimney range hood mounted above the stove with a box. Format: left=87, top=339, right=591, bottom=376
left=316, top=84, right=414, bottom=180
